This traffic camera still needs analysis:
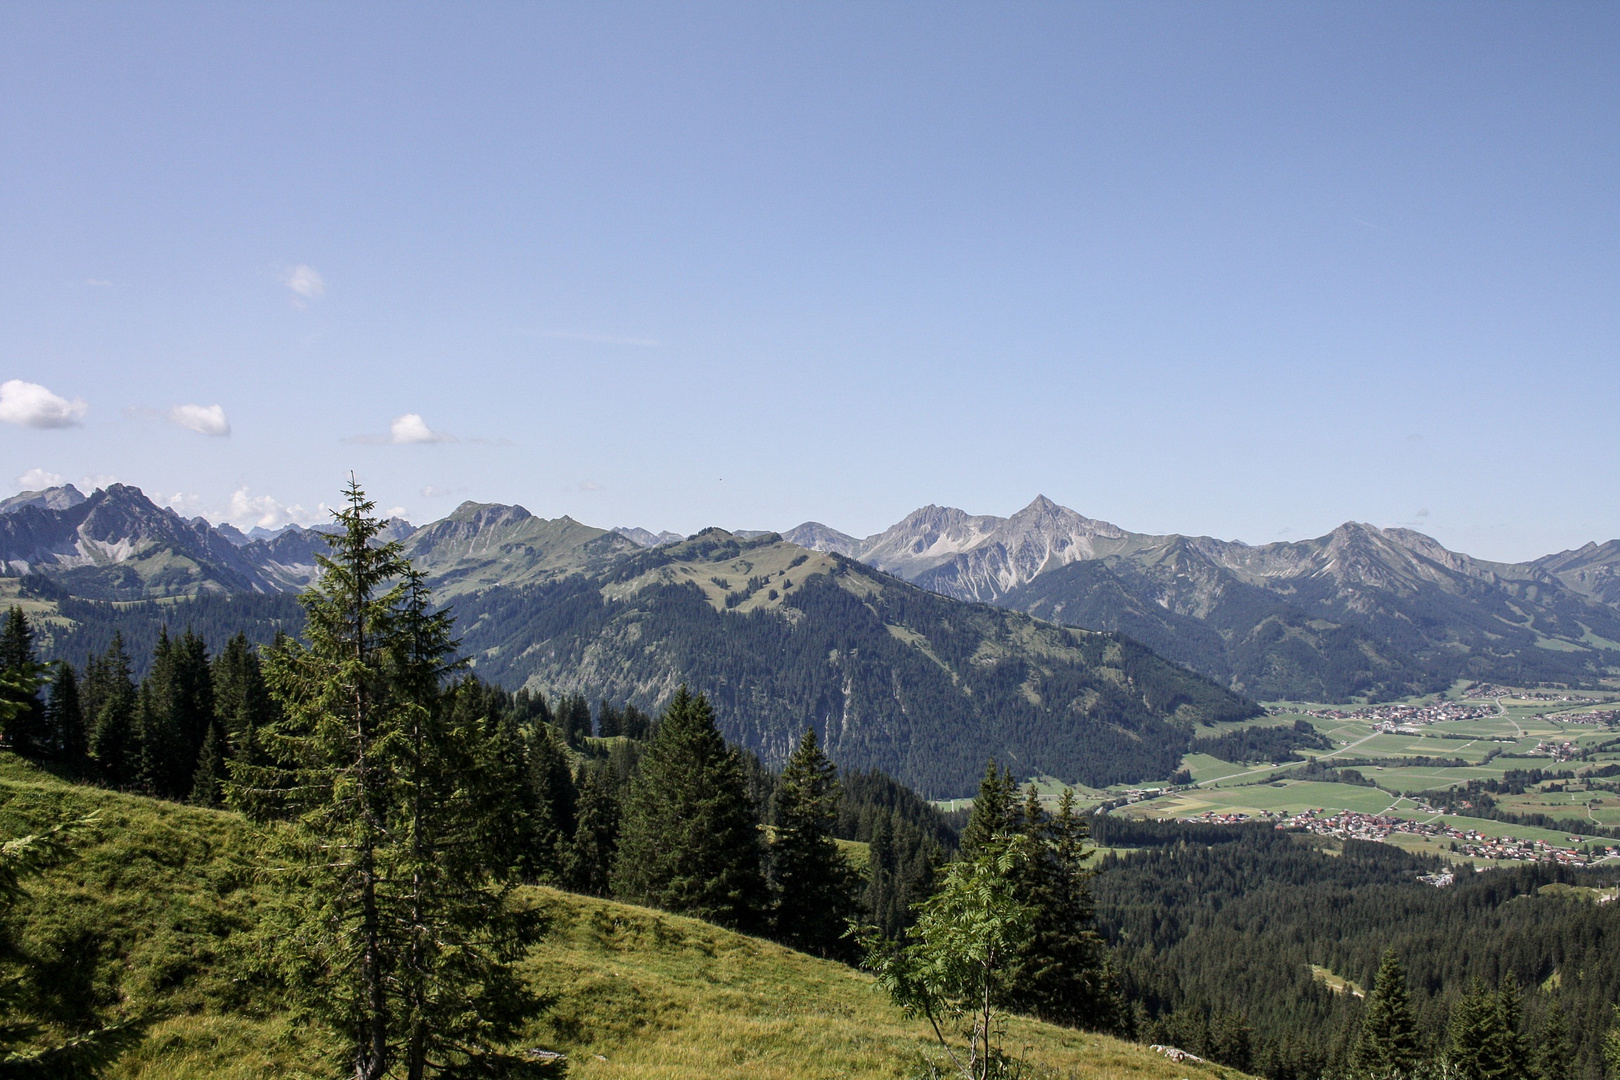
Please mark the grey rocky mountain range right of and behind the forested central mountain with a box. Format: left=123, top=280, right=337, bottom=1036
left=786, top=495, right=1620, bottom=701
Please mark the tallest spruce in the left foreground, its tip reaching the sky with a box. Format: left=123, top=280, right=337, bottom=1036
left=232, top=484, right=535, bottom=1080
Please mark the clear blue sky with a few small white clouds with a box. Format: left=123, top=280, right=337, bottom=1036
left=0, top=3, right=1620, bottom=559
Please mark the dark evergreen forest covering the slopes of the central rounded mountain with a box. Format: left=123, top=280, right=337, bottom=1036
left=457, top=563, right=1257, bottom=797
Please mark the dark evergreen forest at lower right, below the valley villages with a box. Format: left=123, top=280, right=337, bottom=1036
left=1094, top=818, right=1620, bottom=1080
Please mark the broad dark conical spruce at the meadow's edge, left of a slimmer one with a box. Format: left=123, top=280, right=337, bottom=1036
left=612, top=685, right=766, bottom=931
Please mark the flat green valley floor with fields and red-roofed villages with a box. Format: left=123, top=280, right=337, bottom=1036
left=1100, top=683, right=1620, bottom=884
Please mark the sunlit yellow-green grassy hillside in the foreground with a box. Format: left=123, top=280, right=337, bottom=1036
left=0, top=755, right=1238, bottom=1080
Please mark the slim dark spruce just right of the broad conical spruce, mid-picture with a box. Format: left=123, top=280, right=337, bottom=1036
left=770, top=729, right=859, bottom=959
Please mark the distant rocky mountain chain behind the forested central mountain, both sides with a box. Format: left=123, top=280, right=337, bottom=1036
left=9, top=486, right=1620, bottom=701
